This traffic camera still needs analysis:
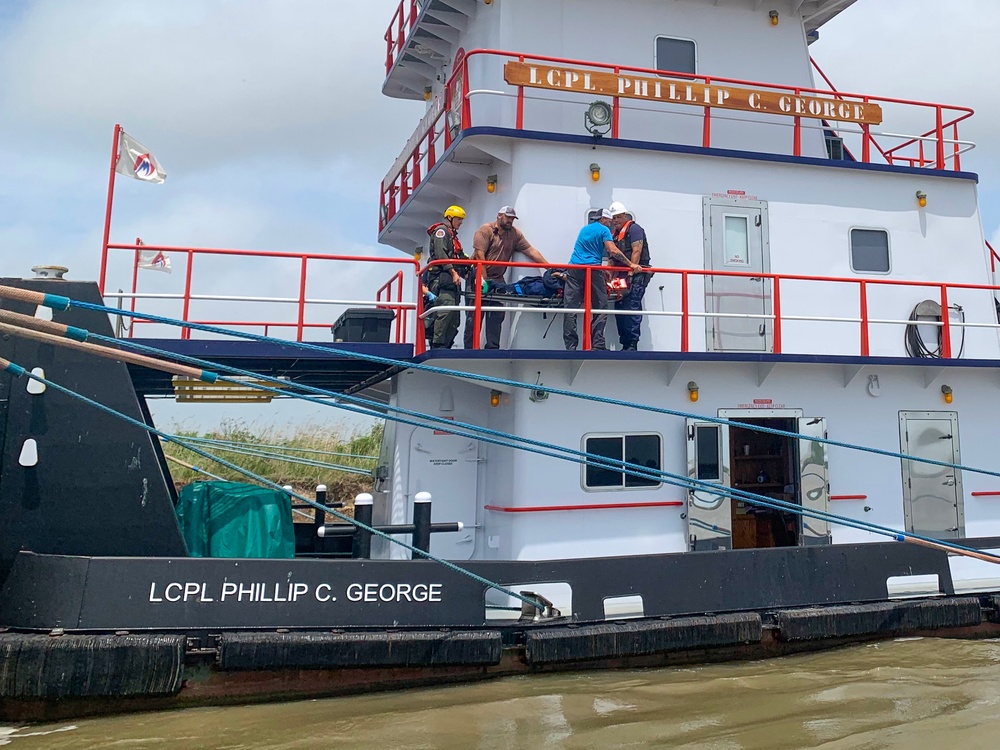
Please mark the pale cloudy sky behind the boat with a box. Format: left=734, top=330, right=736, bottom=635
left=0, top=0, right=1000, bottom=432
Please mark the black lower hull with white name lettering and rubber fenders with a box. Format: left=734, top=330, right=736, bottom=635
left=0, top=540, right=1000, bottom=721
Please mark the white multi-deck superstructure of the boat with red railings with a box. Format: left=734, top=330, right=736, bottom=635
left=376, top=0, right=1000, bottom=592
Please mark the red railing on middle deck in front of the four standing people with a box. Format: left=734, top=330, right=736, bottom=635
left=416, top=260, right=1000, bottom=359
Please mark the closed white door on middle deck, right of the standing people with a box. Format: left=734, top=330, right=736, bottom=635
left=705, top=199, right=774, bottom=352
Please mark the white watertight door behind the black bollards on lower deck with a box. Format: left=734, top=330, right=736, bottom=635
left=406, top=427, right=479, bottom=560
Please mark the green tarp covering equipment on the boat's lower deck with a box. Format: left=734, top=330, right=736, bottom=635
left=177, top=482, right=295, bottom=558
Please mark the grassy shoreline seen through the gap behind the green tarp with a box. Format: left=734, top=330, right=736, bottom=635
left=163, top=421, right=382, bottom=504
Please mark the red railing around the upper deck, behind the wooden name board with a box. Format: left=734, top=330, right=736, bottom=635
left=379, top=50, right=974, bottom=231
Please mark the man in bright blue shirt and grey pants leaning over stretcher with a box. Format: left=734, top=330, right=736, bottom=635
left=563, top=209, right=640, bottom=351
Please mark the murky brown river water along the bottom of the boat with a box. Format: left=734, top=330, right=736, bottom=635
left=0, top=639, right=1000, bottom=750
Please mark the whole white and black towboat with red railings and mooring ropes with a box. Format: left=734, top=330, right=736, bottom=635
left=0, top=0, right=1000, bottom=720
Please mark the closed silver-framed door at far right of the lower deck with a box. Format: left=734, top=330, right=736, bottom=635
left=899, top=412, right=965, bottom=539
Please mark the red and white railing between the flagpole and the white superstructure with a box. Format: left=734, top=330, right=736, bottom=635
left=105, top=241, right=423, bottom=343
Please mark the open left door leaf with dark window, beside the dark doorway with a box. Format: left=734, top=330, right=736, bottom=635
left=687, top=419, right=733, bottom=551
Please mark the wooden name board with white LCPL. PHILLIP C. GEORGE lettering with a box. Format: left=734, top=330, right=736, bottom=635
left=504, top=62, right=882, bottom=125
